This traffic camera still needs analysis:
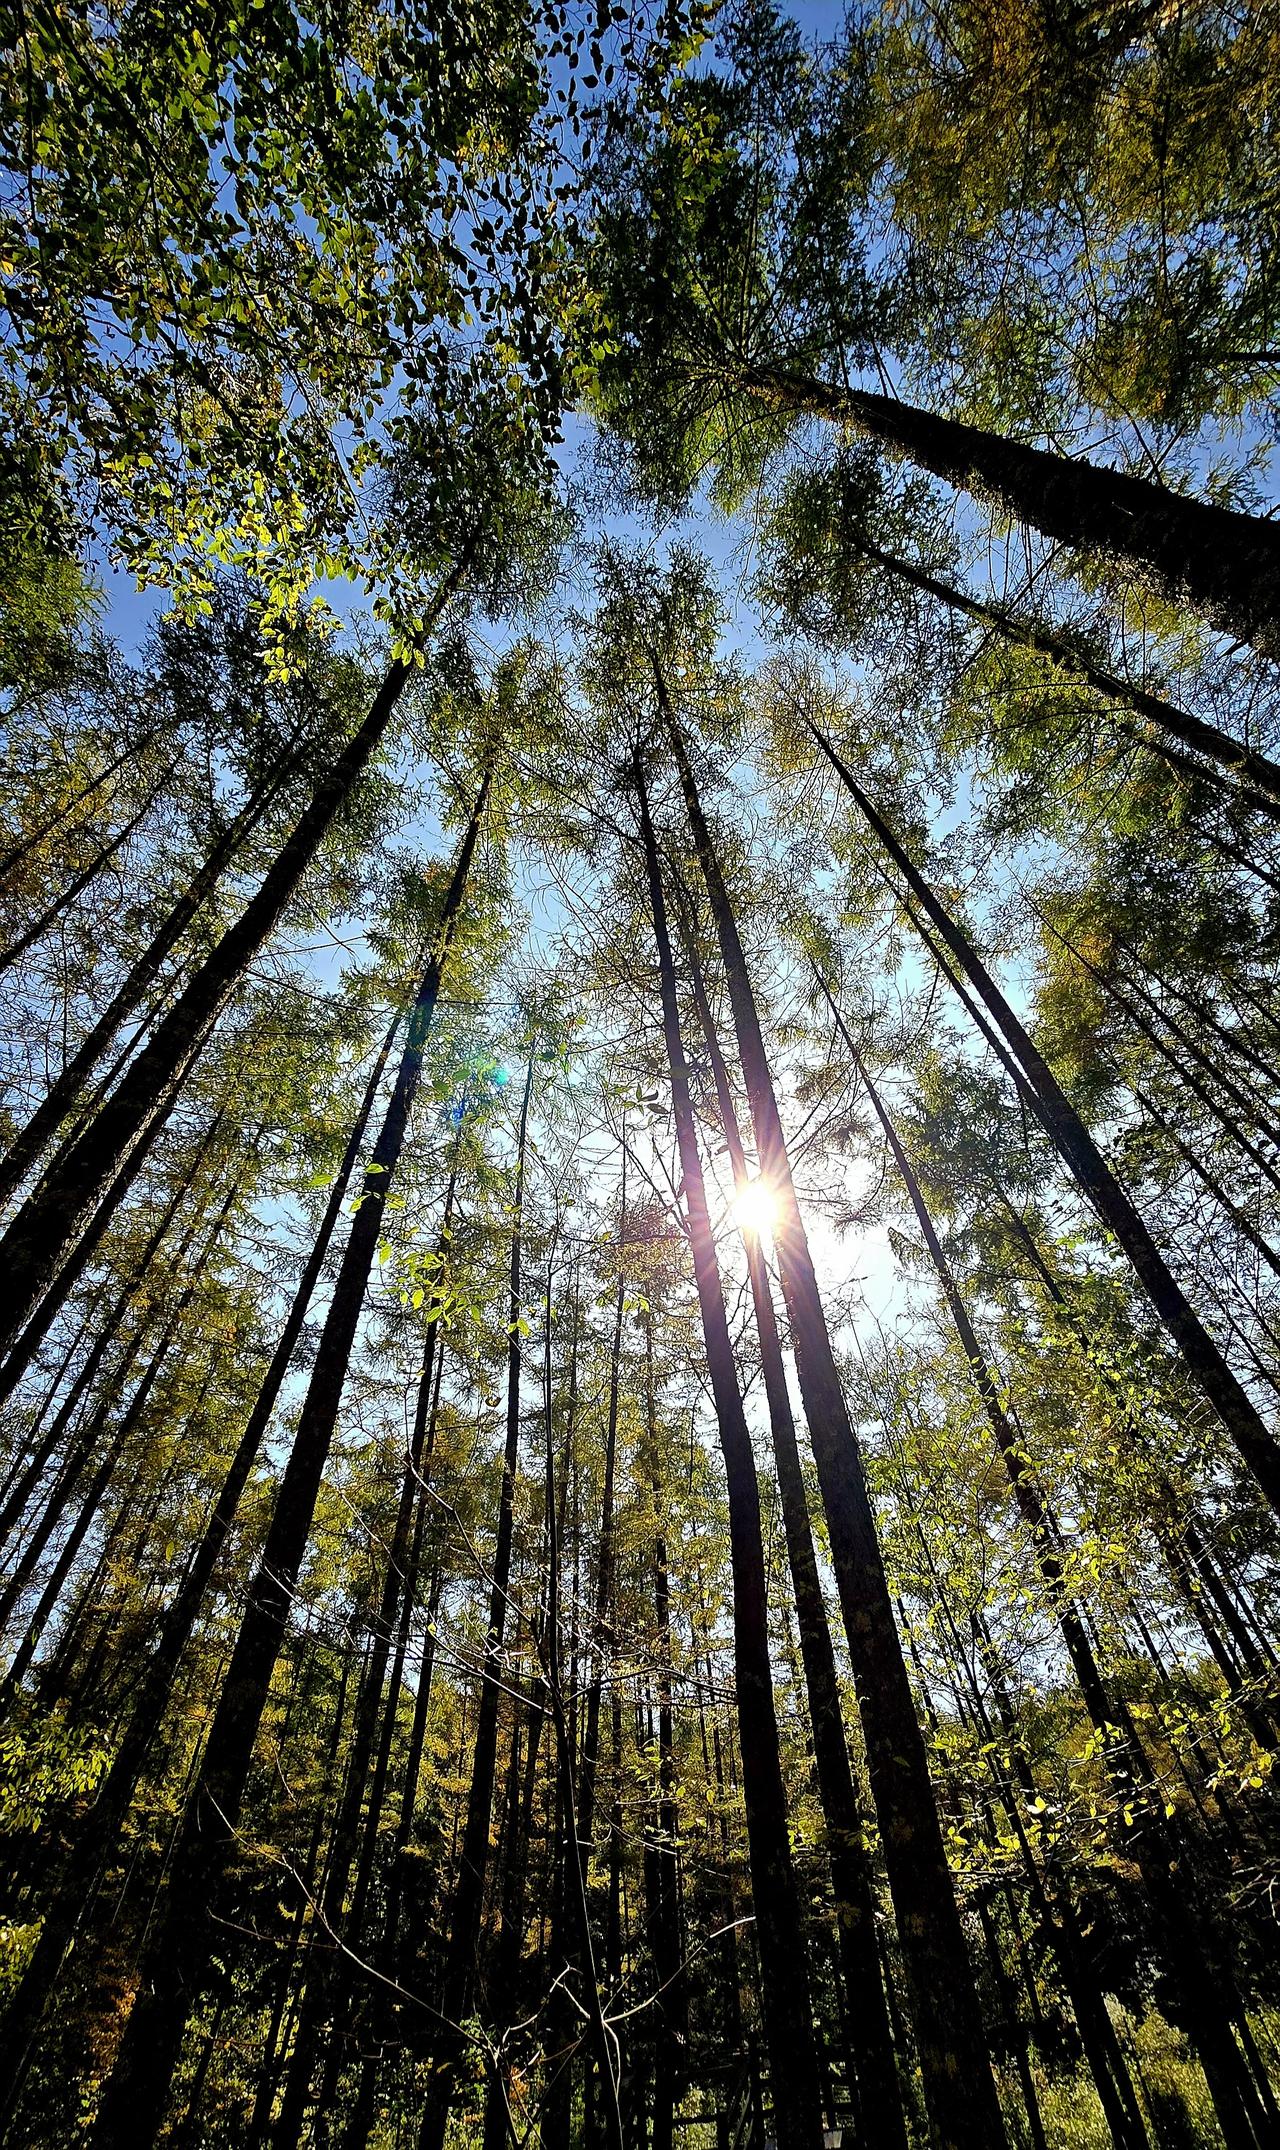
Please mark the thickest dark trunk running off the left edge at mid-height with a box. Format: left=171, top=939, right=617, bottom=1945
left=0, top=565, right=463, bottom=1378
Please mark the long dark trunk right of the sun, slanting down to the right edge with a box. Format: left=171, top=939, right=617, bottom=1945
left=809, top=725, right=1280, bottom=1509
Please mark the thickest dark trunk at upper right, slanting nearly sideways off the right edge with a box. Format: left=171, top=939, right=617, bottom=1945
left=725, top=366, right=1280, bottom=651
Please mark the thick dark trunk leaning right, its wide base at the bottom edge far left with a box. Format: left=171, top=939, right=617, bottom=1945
left=83, top=772, right=490, bottom=2150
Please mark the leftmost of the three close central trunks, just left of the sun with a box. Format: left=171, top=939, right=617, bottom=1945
left=635, top=765, right=822, bottom=2150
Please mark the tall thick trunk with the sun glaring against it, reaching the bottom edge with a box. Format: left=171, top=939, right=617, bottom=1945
left=654, top=709, right=1005, bottom=2150
